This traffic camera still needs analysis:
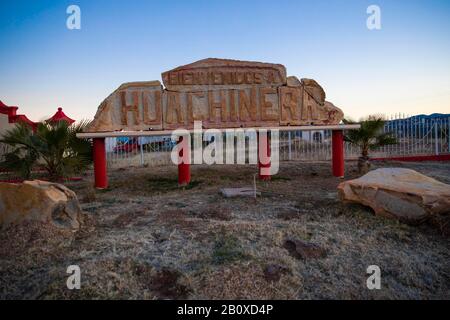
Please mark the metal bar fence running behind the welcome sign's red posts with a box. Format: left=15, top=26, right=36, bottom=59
left=106, top=115, right=450, bottom=168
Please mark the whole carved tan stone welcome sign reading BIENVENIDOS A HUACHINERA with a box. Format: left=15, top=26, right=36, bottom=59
left=87, top=59, right=343, bottom=132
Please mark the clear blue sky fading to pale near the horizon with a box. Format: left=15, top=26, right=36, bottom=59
left=0, top=0, right=450, bottom=121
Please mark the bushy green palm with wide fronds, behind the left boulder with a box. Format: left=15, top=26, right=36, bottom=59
left=0, top=121, right=92, bottom=181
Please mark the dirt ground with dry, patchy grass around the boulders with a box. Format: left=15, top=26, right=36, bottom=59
left=0, top=162, right=450, bottom=299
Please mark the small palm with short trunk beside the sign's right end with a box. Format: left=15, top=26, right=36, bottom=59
left=344, top=115, right=397, bottom=173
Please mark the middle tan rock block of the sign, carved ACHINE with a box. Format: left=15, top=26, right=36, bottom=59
left=163, top=86, right=280, bottom=130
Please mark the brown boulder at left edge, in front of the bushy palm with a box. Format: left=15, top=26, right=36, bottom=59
left=0, top=180, right=82, bottom=230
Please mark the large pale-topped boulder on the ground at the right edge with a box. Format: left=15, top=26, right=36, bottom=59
left=338, top=168, right=450, bottom=223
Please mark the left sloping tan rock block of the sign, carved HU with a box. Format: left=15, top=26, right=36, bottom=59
left=85, top=81, right=163, bottom=132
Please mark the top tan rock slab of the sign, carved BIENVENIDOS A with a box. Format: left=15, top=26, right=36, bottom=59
left=162, top=58, right=286, bottom=92
